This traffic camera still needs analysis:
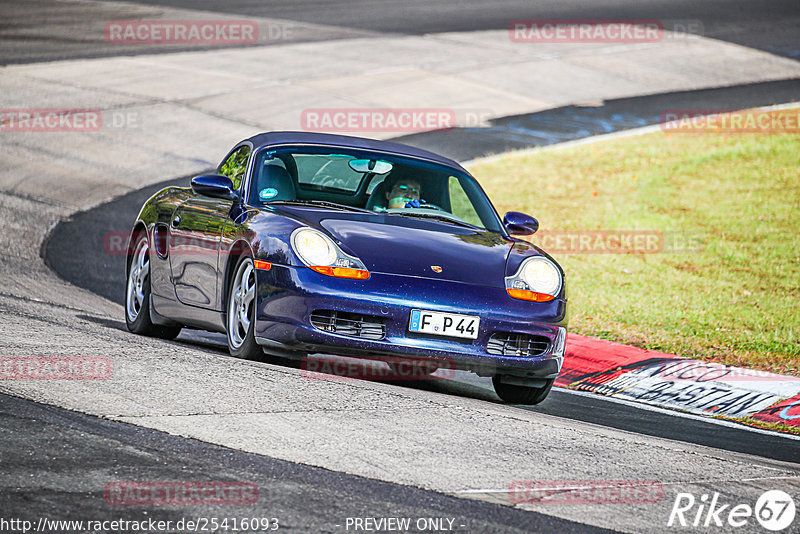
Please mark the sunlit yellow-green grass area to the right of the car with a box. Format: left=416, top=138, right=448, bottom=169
left=471, top=108, right=800, bottom=376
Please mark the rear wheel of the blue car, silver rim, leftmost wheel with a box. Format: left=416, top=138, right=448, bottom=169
left=125, top=232, right=181, bottom=339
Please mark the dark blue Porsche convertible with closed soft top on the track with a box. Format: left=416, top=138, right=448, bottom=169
left=125, top=132, right=567, bottom=404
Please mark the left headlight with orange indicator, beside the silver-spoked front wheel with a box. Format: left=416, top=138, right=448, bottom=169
left=292, top=228, right=369, bottom=280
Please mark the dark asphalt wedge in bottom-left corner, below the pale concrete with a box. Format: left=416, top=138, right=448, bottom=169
left=0, top=395, right=612, bottom=533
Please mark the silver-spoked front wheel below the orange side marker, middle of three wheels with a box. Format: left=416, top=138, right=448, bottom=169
left=227, top=256, right=264, bottom=360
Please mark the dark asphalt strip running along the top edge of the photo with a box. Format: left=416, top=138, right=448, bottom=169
left=0, top=0, right=800, bottom=63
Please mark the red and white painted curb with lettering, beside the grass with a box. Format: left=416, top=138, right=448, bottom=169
left=556, top=334, right=800, bottom=434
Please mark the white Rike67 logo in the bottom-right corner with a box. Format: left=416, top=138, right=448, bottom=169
left=667, top=490, right=795, bottom=532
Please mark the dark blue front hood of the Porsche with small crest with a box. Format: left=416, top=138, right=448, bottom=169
left=318, top=215, right=513, bottom=287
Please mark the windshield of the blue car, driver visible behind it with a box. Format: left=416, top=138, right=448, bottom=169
left=249, top=146, right=501, bottom=232
